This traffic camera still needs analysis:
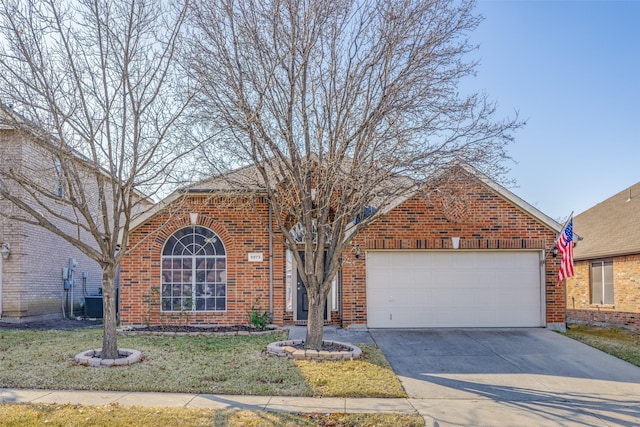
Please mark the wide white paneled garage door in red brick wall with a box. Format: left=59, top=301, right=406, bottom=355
left=367, top=251, right=544, bottom=328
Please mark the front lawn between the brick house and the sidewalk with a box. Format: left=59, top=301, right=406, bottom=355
left=0, top=329, right=406, bottom=397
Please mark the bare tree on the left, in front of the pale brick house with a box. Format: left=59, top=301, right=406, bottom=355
left=0, top=0, right=193, bottom=358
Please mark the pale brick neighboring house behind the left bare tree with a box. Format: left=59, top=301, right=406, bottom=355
left=0, top=113, right=102, bottom=322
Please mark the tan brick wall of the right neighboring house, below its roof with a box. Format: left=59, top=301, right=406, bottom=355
left=567, top=255, right=640, bottom=328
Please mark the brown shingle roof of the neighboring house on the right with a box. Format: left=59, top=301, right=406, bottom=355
left=573, top=182, right=640, bottom=260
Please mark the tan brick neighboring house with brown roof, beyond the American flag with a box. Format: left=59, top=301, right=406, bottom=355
left=567, top=182, right=640, bottom=328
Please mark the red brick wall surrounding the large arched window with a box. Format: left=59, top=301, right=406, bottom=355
left=120, top=197, right=285, bottom=325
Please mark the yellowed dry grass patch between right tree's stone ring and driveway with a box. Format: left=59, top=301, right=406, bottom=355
left=296, top=345, right=407, bottom=397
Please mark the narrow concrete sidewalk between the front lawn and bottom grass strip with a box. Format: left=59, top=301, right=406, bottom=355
left=0, top=389, right=417, bottom=414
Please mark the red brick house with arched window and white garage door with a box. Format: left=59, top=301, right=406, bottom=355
left=120, top=169, right=566, bottom=330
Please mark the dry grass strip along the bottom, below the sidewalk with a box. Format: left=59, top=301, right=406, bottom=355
left=0, top=404, right=424, bottom=427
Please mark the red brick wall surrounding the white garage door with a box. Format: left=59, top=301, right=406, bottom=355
left=343, top=177, right=565, bottom=325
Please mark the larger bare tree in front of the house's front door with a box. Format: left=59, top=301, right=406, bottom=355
left=189, top=0, right=521, bottom=348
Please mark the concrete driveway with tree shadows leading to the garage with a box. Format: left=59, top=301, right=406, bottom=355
left=369, top=329, right=640, bottom=427
